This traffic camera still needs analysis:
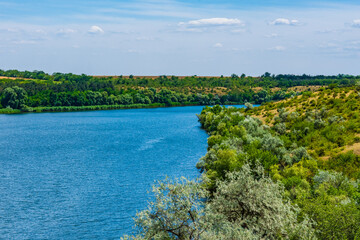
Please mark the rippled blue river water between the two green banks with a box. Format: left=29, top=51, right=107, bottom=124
left=0, top=107, right=245, bottom=239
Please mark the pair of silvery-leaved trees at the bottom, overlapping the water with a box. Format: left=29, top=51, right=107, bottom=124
left=125, top=165, right=315, bottom=240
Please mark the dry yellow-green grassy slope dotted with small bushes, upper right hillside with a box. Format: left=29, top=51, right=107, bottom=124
left=246, top=87, right=360, bottom=160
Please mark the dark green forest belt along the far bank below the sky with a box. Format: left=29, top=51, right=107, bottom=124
left=0, top=70, right=360, bottom=113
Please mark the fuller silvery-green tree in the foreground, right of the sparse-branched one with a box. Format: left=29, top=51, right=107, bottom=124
left=211, top=164, right=315, bottom=239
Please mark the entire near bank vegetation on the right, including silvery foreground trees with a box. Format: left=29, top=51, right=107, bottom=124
left=123, top=83, right=360, bottom=239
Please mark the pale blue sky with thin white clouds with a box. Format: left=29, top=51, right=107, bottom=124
left=0, top=0, right=360, bottom=75
